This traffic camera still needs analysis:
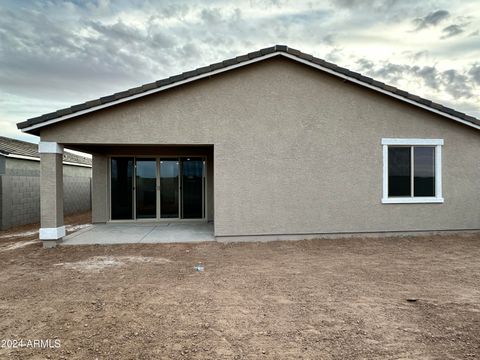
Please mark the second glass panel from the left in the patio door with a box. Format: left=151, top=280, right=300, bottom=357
left=135, top=159, right=157, bottom=219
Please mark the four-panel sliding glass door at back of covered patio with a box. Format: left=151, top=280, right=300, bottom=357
left=110, top=157, right=206, bottom=220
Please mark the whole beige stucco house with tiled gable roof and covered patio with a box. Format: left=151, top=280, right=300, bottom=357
left=18, top=45, right=480, bottom=246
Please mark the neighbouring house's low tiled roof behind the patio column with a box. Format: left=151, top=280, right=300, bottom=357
left=0, top=136, right=92, bottom=166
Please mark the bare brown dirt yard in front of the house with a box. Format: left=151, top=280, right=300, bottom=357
left=0, top=215, right=480, bottom=359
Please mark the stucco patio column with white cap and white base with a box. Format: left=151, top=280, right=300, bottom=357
left=38, top=141, right=65, bottom=248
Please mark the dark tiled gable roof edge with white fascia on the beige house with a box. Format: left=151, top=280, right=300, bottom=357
left=17, top=45, right=480, bottom=133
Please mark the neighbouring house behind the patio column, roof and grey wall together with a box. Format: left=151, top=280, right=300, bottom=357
left=0, top=136, right=92, bottom=230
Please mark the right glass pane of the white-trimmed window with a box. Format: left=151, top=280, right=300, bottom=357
left=413, top=146, right=435, bottom=196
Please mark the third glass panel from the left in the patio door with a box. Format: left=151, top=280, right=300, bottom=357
left=160, top=158, right=180, bottom=219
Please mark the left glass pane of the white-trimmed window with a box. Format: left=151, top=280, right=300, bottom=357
left=388, top=146, right=412, bottom=197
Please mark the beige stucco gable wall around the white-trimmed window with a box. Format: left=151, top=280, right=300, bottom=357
left=41, top=59, right=480, bottom=236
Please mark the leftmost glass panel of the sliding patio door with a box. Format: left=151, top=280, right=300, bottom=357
left=110, top=157, right=133, bottom=220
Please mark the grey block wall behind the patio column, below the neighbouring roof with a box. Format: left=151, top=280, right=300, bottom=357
left=0, top=157, right=91, bottom=230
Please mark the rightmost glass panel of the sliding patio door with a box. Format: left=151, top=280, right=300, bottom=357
left=181, top=158, right=203, bottom=219
